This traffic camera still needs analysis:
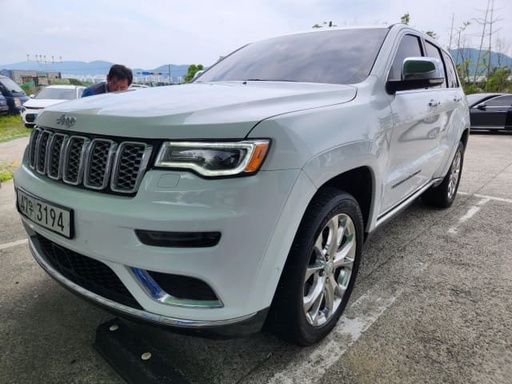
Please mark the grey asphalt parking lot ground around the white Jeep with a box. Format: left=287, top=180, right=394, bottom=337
left=0, top=134, right=512, bottom=384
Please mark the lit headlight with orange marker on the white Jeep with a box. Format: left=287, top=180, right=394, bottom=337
left=155, top=140, right=270, bottom=177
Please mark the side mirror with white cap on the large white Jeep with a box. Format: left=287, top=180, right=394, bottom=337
left=386, top=57, right=444, bottom=94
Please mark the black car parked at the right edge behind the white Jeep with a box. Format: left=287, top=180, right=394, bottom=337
left=467, top=93, right=512, bottom=130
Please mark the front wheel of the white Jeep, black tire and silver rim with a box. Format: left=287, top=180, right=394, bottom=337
left=267, top=189, right=363, bottom=346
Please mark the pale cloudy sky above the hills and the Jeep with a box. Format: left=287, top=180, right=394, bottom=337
left=0, top=0, right=512, bottom=69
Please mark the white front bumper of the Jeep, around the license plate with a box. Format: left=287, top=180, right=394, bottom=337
left=15, top=165, right=313, bottom=336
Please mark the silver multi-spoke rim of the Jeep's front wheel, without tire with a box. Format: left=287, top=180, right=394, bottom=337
left=303, top=214, right=356, bottom=327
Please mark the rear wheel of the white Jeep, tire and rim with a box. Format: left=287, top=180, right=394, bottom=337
left=422, top=142, right=464, bottom=208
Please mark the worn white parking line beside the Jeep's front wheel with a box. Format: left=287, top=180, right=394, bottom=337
left=269, top=291, right=402, bottom=384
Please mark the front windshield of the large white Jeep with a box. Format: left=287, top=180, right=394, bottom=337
left=195, top=28, right=388, bottom=84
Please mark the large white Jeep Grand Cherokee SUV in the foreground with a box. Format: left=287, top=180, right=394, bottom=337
left=15, top=25, right=469, bottom=345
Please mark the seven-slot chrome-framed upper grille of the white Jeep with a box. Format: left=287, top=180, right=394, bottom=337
left=29, top=127, right=152, bottom=194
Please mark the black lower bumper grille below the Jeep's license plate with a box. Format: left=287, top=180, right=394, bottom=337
left=34, top=235, right=142, bottom=309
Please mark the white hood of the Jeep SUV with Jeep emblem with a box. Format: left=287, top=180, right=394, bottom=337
left=36, top=82, right=356, bottom=138
